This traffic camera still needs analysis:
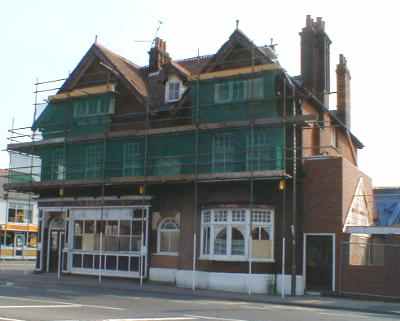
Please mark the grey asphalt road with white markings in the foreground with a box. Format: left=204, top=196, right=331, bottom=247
left=0, top=263, right=398, bottom=321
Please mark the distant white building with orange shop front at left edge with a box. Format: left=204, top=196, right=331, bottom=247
left=0, top=169, right=38, bottom=259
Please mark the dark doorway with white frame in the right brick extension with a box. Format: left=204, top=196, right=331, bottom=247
left=304, top=234, right=335, bottom=292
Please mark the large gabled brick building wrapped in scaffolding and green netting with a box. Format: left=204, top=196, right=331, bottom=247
left=3, top=16, right=373, bottom=294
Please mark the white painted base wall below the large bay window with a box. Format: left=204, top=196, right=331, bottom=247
left=149, top=268, right=304, bottom=295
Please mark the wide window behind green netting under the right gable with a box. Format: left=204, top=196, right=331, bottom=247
left=214, top=77, right=264, bottom=104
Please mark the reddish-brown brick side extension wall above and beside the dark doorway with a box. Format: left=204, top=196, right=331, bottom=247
left=303, top=157, right=374, bottom=289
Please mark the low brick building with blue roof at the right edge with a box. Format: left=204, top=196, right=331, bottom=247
left=340, top=187, right=400, bottom=299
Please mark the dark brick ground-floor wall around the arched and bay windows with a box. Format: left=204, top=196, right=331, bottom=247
left=149, top=180, right=291, bottom=273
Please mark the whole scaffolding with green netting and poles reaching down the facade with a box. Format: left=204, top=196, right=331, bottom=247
left=4, top=43, right=334, bottom=289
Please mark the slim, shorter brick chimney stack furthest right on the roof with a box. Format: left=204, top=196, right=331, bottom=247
left=336, top=54, right=351, bottom=129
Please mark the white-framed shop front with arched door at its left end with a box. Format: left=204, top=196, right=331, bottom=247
left=36, top=196, right=149, bottom=278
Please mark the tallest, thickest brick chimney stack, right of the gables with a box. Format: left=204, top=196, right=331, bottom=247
left=300, top=15, right=331, bottom=107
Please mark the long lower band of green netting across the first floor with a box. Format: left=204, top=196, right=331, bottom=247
left=38, top=127, right=283, bottom=181
